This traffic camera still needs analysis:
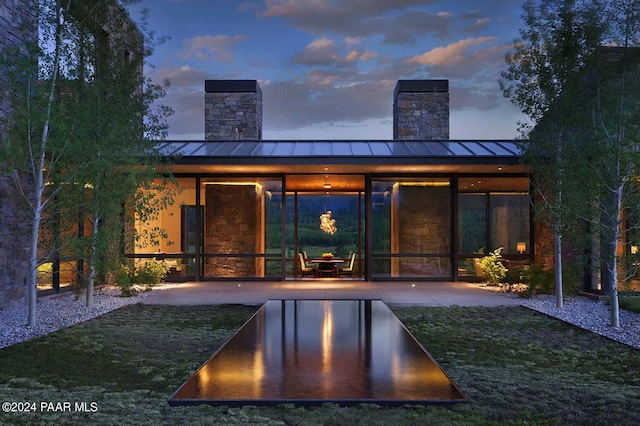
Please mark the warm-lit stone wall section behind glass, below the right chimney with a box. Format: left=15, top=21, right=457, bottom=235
left=391, top=185, right=451, bottom=277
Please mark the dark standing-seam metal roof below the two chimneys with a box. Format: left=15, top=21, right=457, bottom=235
left=160, top=140, right=521, bottom=164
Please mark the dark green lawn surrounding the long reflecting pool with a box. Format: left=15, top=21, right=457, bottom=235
left=0, top=305, right=640, bottom=426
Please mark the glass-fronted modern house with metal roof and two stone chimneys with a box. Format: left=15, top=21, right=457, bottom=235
left=127, top=80, right=543, bottom=281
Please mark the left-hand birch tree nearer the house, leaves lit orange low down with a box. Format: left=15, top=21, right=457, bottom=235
left=53, top=0, right=172, bottom=306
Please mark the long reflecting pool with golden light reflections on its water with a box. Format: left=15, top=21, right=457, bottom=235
left=169, top=300, right=466, bottom=405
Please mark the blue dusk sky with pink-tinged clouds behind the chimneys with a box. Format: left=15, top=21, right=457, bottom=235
left=132, top=0, right=524, bottom=140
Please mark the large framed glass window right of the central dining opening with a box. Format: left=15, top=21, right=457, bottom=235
left=371, top=178, right=451, bottom=279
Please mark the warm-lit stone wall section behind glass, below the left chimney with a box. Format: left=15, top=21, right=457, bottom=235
left=204, top=185, right=265, bottom=278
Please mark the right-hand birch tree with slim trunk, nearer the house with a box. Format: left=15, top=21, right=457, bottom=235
left=500, top=0, right=599, bottom=308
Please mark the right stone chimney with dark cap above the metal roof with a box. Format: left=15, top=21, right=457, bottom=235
left=393, top=80, right=449, bottom=140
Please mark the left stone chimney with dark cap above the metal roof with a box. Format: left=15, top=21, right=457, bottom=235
left=204, top=80, right=262, bottom=140
